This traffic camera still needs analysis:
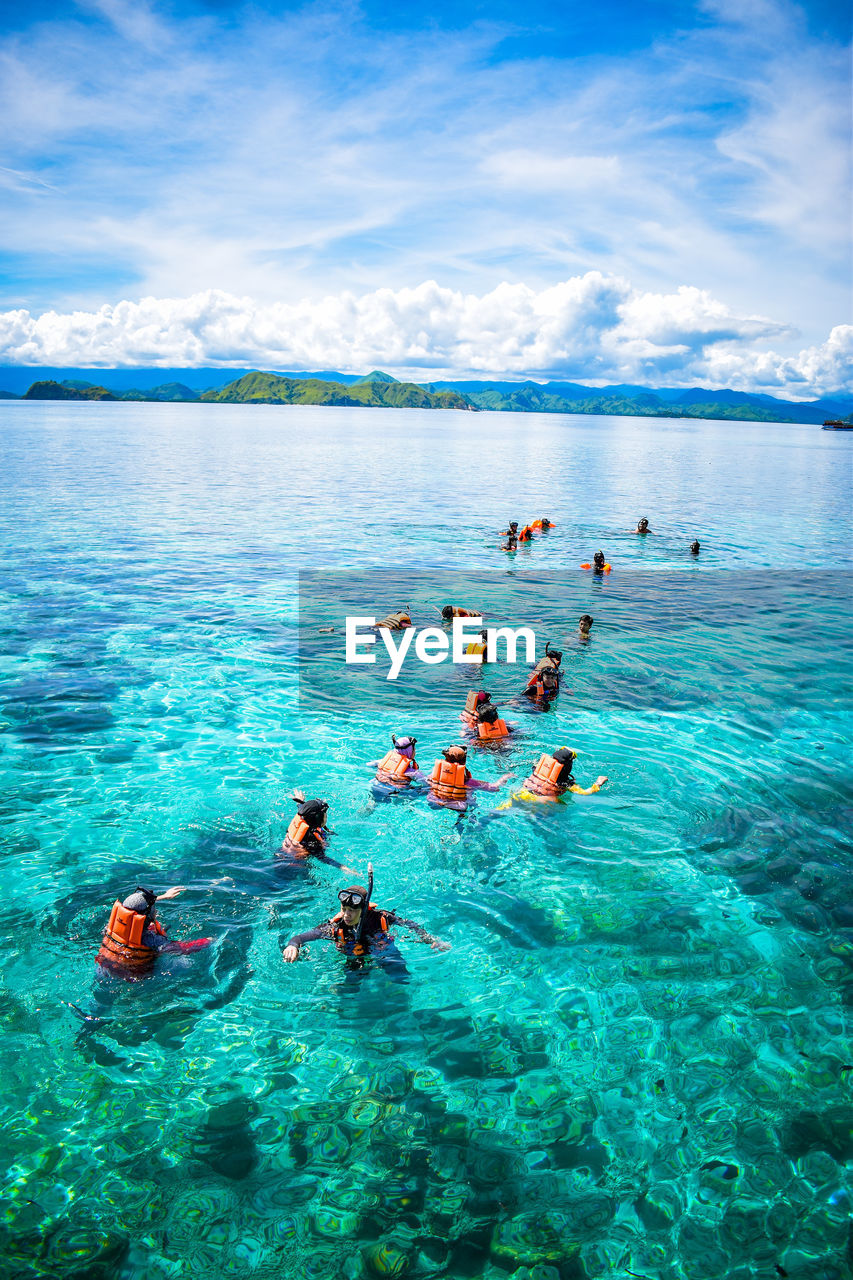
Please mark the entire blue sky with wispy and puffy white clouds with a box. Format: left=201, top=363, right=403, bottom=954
left=0, top=0, right=853, bottom=399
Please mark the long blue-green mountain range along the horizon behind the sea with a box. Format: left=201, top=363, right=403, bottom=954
left=0, top=366, right=853, bottom=422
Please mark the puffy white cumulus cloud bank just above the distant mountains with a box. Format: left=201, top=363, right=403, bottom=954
left=0, top=271, right=853, bottom=399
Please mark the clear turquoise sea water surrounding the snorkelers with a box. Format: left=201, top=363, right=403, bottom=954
left=0, top=403, right=853, bottom=1280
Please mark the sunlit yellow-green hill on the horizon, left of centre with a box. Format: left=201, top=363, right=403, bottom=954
left=201, top=374, right=471, bottom=408
